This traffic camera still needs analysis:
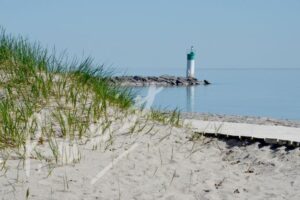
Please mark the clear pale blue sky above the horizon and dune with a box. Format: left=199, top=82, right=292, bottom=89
left=0, top=0, right=300, bottom=70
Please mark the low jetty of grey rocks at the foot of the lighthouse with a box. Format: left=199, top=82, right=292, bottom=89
left=110, top=75, right=210, bottom=86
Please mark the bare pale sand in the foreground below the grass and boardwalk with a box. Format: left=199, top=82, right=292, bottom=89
left=0, top=119, right=300, bottom=200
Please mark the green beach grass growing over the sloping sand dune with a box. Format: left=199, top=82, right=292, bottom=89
left=0, top=28, right=182, bottom=171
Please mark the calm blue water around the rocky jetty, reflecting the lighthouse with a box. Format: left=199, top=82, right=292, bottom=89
left=116, top=68, right=300, bottom=120
